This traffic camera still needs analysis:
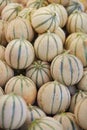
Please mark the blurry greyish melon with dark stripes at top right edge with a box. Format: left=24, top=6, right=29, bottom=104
left=66, top=0, right=85, bottom=15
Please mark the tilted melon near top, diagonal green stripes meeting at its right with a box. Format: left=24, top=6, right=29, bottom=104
left=31, top=7, right=60, bottom=33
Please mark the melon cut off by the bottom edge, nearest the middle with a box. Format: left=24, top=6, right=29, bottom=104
left=28, top=117, right=63, bottom=130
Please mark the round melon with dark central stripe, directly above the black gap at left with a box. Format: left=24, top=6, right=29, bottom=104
left=5, top=38, right=35, bottom=69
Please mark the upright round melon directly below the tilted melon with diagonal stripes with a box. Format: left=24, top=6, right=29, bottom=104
left=34, top=32, right=63, bottom=61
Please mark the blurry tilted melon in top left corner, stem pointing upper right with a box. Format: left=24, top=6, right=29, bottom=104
left=1, top=3, right=23, bottom=22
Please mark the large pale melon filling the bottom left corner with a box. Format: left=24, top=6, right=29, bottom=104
left=0, top=94, right=27, bottom=129
